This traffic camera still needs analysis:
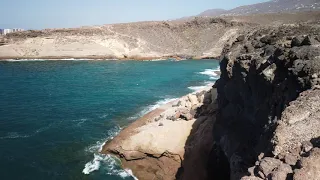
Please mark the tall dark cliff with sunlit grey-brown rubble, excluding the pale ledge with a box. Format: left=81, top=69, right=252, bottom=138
left=211, top=22, right=320, bottom=180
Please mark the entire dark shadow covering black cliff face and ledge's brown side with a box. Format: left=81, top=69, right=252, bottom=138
left=176, top=51, right=310, bottom=180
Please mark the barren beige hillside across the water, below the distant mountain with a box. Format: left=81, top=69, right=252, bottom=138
left=0, top=12, right=320, bottom=59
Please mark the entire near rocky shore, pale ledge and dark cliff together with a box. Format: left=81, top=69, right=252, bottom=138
left=102, top=19, right=320, bottom=180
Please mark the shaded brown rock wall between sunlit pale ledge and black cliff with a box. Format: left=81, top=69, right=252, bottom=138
left=176, top=88, right=230, bottom=180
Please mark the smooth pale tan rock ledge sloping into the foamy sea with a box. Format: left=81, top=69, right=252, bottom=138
left=102, top=86, right=216, bottom=180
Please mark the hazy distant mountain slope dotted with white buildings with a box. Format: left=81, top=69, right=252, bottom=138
left=198, top=0, right=320, bottom=16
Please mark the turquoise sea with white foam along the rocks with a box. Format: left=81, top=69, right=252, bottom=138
left=0, top=60, right=218, bottom=180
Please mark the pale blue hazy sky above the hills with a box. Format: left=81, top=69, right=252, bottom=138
left=0, top=0, right=266, bottom=29
